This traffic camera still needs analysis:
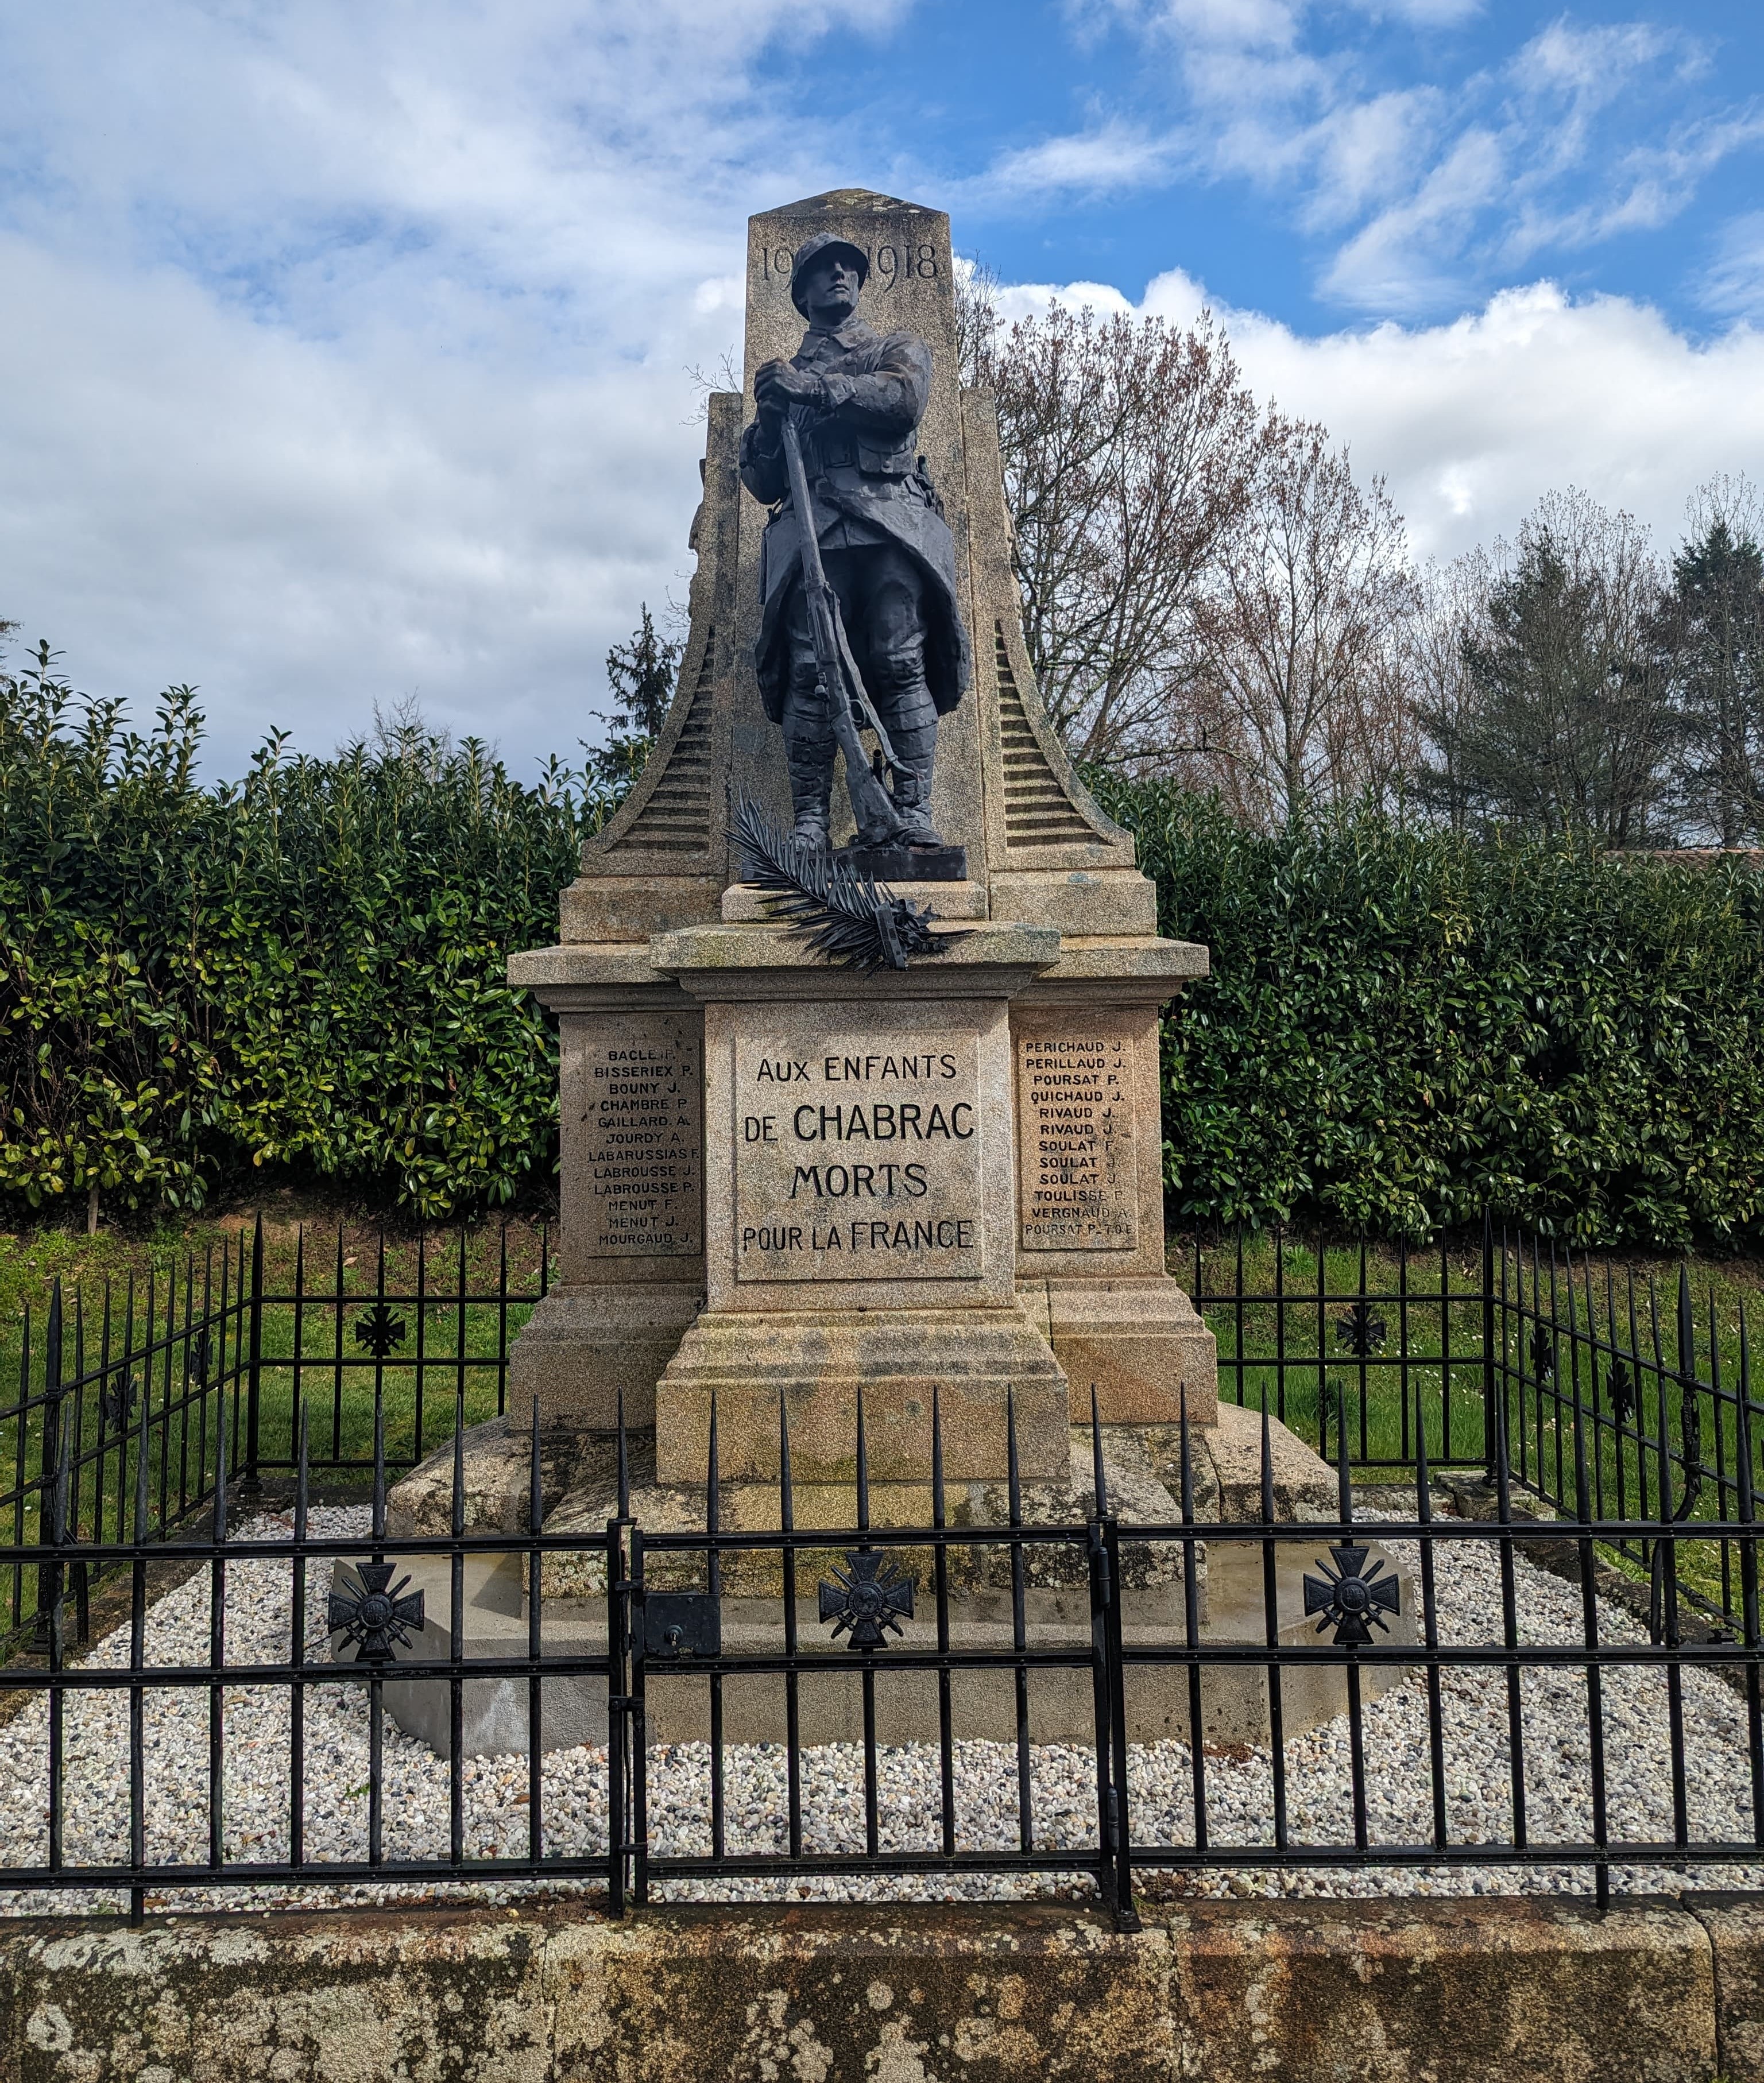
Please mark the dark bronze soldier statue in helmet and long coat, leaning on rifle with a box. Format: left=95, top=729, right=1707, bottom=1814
left=741, top=231, right=969, bottom=875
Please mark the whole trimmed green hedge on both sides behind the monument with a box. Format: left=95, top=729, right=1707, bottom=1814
left=0, top=660, right=1764, bottom=1246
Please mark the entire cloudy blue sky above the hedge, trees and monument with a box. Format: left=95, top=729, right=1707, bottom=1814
left=0, top=0, right=1764, bottom=771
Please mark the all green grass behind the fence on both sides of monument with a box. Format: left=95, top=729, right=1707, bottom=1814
left=0, top=1212, right=1764, bottom=1633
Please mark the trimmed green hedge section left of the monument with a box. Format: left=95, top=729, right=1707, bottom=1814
left=0, top=660, right=604, bottom=1217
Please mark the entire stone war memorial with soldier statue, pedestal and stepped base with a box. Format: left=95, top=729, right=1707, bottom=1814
left=373, top=189, right=1408, bottom=1750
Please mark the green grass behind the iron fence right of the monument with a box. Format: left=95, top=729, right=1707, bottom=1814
left=1170, top=1235, right=1764, bottom=1602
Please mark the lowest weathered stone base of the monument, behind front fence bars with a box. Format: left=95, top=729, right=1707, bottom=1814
left=368, top=1404, right=1416, bottom=1756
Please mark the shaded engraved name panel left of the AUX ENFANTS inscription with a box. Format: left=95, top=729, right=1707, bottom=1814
left=591, top=1012, right=704, bottom=1258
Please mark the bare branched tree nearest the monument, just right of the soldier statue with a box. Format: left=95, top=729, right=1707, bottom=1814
left=958, top=269, right=1264, bottom=762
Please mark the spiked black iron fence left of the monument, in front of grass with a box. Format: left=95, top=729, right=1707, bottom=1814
left=0, top=1221, right=550, bottom=1643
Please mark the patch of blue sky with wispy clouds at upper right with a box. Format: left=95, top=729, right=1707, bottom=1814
left=825, top=0, right=1764, bottom=331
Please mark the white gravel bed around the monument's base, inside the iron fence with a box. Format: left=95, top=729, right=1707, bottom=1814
left=0, top=1510, right=1764, bottom=1914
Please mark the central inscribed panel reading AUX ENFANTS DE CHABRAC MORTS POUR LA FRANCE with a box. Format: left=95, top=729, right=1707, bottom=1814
left=735, top=1029, right=983, bottom=1281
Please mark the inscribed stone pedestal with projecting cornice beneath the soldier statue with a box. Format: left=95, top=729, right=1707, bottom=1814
left=510, top=921, right=1216, bottom=1516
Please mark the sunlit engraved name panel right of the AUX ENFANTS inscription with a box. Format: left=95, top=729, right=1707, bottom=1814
left=1016, top=1012, right=1139, bottom=1252
